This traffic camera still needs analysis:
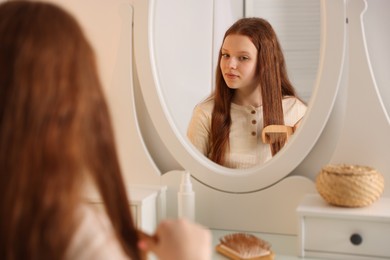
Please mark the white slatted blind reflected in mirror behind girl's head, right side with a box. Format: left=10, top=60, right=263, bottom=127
left=244, top=0, right=321, bottom=101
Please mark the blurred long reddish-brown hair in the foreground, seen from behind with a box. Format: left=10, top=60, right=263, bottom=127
left=0, top=1, right=140, bottom=259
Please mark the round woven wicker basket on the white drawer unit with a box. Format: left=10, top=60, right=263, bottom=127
left=316, top=164, right=384, bottom=207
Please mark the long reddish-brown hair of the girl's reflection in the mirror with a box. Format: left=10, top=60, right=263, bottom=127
left=210, top=18, right=296, bottom=164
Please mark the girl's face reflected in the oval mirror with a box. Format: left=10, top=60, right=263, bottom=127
left=220, top=34, right=258, bottom=90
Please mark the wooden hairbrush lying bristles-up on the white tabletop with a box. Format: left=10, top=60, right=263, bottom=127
left=215, top=233, right=274, bottom=260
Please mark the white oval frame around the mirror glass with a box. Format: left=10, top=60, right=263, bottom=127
left=134, top=0, right=346, bottom=193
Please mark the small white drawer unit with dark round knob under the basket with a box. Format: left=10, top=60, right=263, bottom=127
left=297, top=194, right=390, bottom=259
